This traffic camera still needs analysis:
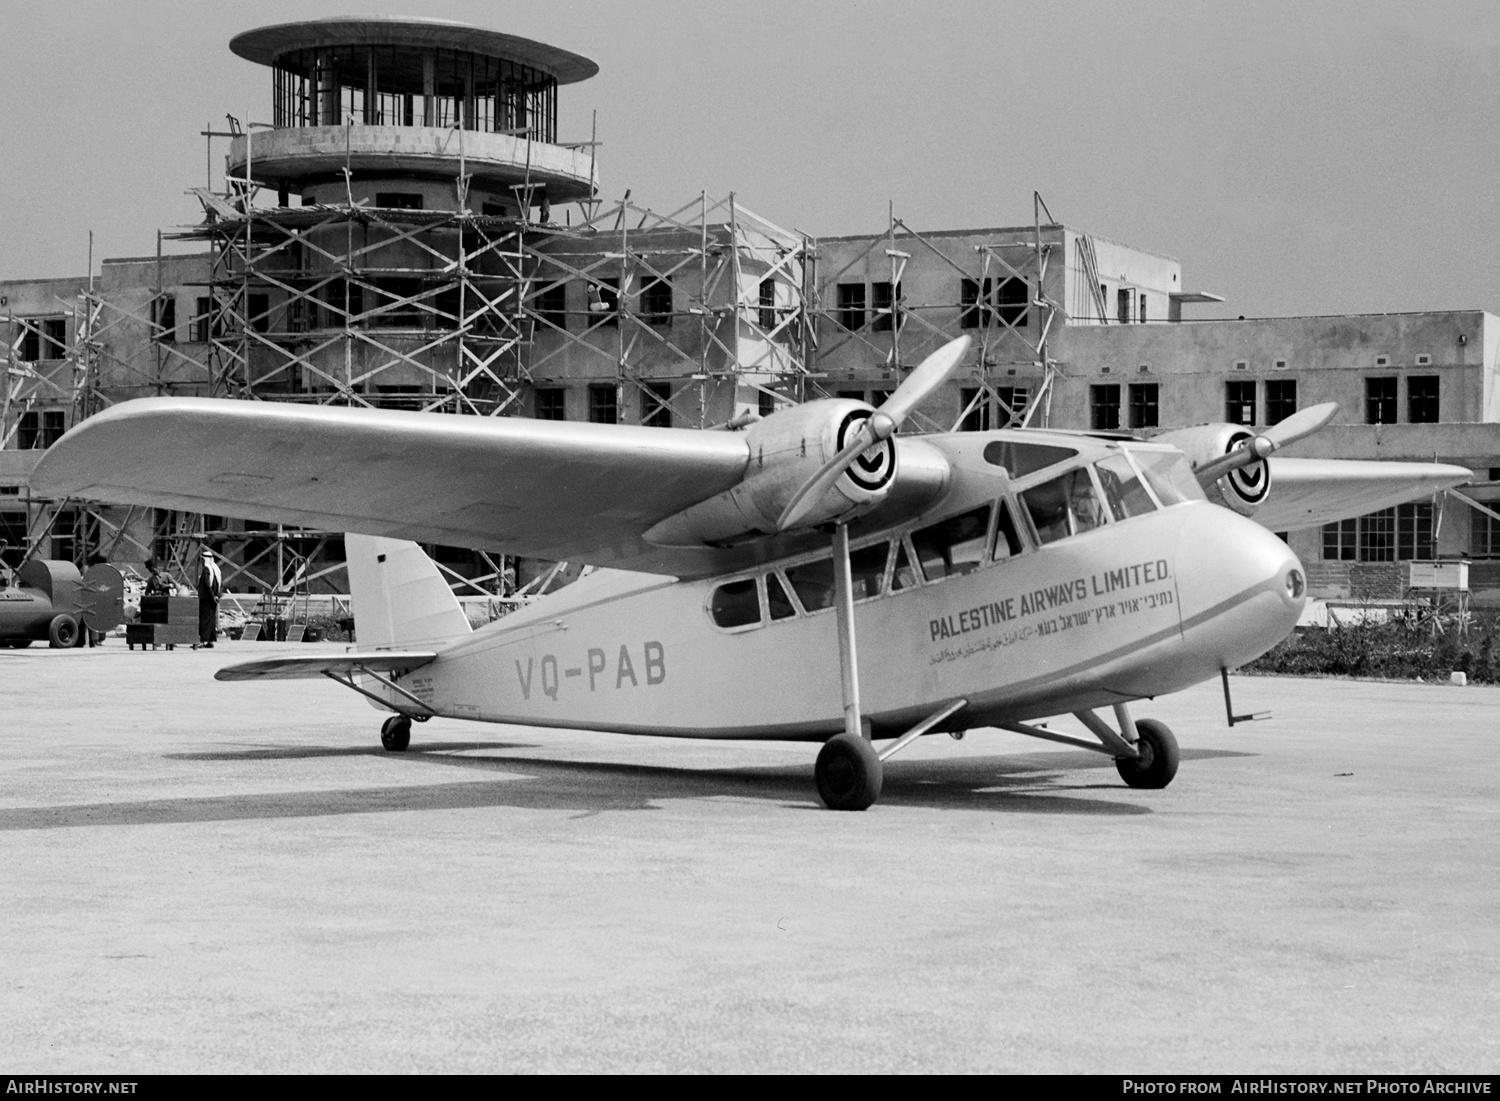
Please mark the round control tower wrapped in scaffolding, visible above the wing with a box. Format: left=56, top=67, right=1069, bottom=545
left=182, top=18, right=599, bottom=414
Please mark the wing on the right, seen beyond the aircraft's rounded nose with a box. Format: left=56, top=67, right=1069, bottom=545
left=1253, top=456, right=1473, bottom=531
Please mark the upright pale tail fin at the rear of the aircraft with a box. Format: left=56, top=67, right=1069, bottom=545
left=344, top=536, right=471, bottom=648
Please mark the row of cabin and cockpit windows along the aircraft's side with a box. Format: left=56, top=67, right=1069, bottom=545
left=708, top=441, right=1203, bottom=630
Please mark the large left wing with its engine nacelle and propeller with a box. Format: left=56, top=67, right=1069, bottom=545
left=30, top=338, right=969, bottom=576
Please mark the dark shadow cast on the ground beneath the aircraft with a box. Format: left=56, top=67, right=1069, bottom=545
left=0, top=743, right=1253, bottom=831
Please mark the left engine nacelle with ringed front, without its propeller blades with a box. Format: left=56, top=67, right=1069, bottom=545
left=647, top=398, right=897, bottom=546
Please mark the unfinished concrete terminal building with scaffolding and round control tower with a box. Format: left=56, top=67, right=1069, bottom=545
left=0, top=18, right=1500, bottom=609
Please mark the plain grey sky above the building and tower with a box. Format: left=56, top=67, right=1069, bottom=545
left=0, top=0, right=1500, bottom=318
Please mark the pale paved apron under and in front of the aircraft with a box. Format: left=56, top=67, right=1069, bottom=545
left=0, top=639, right=1500, bottom=1074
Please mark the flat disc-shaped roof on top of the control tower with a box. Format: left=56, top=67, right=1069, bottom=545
left=230, top=15, right=599, bottom=84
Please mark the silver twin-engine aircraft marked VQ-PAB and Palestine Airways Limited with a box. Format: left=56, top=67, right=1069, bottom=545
left=32, top=339, right=1470, bottom=809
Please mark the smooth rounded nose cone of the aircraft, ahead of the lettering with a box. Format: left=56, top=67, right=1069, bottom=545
left=1178, top=504, right=1307, bottom=668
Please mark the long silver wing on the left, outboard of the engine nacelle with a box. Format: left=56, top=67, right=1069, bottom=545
left=30, top=398, right=750, bottom=579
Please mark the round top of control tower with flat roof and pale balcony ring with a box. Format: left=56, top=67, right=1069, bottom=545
left=228, top=18, right=599, bottom=221
